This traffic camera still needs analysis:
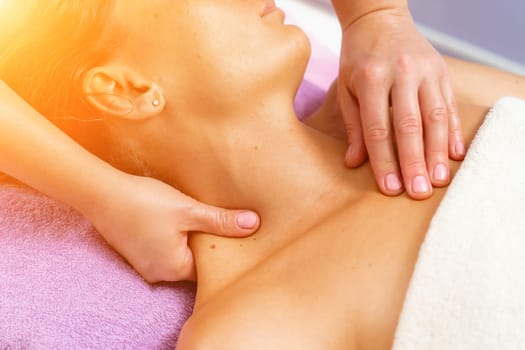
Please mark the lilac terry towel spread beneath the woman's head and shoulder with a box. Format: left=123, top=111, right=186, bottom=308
left=0, top=82, right=324, bottom=349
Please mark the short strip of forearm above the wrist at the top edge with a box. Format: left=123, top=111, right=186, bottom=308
left=332, top=0, right=409, bottom=28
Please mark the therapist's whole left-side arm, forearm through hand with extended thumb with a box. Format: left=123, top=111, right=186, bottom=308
left=0, top=81, right=259, bottom=282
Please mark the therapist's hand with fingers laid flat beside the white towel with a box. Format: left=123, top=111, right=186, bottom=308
left=338, top=7, right=465, bottom=199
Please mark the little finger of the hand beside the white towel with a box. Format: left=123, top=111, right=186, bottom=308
left=441, top=78, right=466, bottom=160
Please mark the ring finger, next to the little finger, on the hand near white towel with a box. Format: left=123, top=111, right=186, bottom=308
left=419, top=81, right=450, bottom=187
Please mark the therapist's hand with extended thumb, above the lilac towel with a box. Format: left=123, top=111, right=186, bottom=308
left=88, top=174, right=259, bottom=283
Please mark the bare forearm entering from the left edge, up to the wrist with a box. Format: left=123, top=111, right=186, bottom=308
left=0, top=81, right=122, bottom=220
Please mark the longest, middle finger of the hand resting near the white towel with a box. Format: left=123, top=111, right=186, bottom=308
left=392, top=76, right=432, bottom=199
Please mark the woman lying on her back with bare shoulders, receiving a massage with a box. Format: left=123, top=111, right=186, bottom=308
left=0, top=0, right=525, bottom=350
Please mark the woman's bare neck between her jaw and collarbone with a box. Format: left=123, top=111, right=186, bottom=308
left=142, top=94, right=371, bottom=234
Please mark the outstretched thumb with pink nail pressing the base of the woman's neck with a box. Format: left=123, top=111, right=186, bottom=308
left=184, top=203, right=260, bottom=237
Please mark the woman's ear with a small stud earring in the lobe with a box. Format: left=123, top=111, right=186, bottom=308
left=82, top=66, right=166, bottom=120
